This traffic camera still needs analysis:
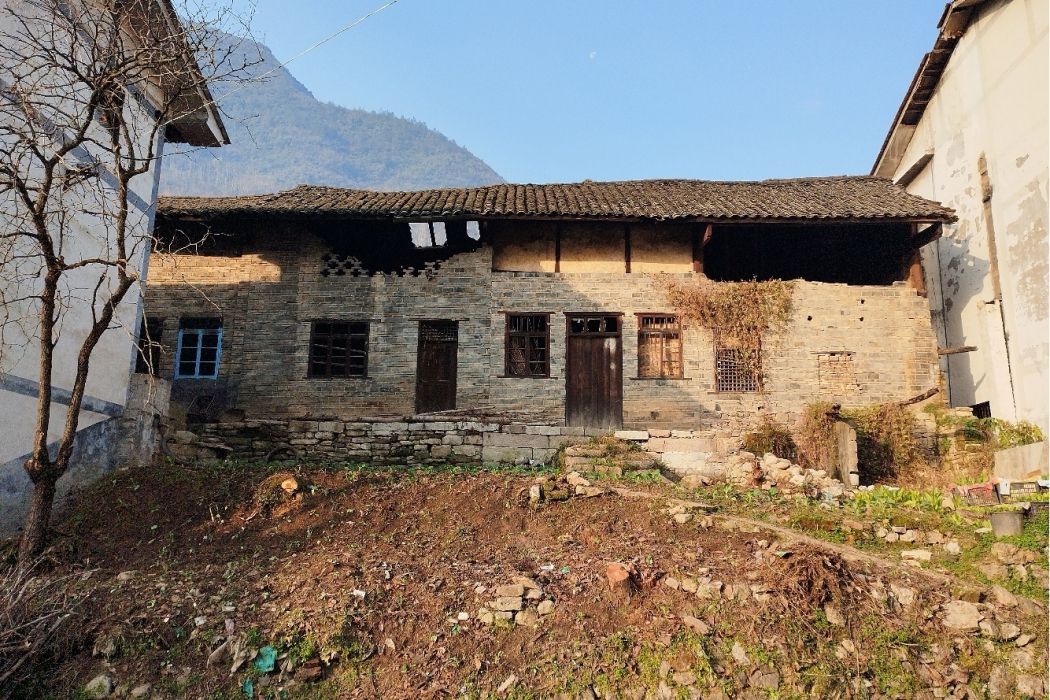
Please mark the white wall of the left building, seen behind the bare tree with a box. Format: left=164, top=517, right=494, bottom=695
left=0, top=0, right=168, bottom=536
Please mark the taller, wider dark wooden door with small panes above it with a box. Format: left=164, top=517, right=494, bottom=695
left=565, top=314, right=624, bottom=428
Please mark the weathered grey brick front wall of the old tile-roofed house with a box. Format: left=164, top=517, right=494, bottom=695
left=146, top=225, right=938, bottom=428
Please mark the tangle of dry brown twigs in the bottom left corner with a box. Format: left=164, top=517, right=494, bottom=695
left=0, top=563, right=80, bottom=698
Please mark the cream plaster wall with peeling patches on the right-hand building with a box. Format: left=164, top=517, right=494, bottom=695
left=894, top=0, right=1050, bottom=431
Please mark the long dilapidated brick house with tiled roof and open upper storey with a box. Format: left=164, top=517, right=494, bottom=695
left=144, top=177, right=953, bottom=468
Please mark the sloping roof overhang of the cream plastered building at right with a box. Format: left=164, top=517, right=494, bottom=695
left=872, top=0, right=988, bottom=178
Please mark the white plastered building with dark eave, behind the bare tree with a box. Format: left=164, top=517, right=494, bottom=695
left=0, top=0, right=229, bottom=536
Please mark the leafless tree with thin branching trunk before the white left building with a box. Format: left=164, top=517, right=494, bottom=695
left=0, top=0, right=258, bottom=561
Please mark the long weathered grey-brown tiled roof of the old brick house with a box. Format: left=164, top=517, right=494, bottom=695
left=159, top=175, right=954, bottom=221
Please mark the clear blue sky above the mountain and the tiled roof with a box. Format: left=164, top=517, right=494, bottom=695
left=240, top=0, right=944, bottom=183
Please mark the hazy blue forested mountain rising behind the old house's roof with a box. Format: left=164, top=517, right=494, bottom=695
left=161, top=42, right=504, bottom=196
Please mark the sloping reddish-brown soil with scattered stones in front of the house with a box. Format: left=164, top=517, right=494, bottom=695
left=8, top=464, right=1047, bottom=699
